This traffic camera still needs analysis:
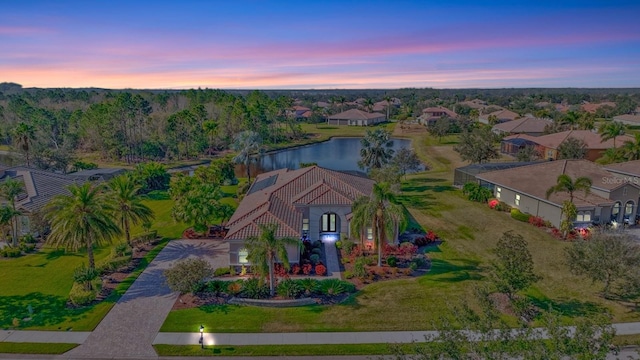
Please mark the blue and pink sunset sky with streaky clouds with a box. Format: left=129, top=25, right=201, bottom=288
left=0, top=0, right=640, bottom=89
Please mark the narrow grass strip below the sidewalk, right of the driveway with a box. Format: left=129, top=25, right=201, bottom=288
left=153, top=344, right=411, bottom=356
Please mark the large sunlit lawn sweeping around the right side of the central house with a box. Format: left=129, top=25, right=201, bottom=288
left=161, top=128, right=640, bottom=332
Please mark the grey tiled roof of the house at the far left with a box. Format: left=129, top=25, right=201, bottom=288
left=0, top=167, right=82, bottom=213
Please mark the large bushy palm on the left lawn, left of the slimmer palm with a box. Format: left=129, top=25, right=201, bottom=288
left=45, top=182, right=122, bottom=270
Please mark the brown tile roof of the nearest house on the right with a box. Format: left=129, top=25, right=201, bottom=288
left=477, top=160, right=621, bottom=208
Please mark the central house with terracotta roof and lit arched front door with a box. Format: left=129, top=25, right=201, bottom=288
left=225, top=166, right=374, bottom=266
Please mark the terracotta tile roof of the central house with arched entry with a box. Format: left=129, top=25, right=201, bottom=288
left=226, top=166, right=374, bottom=239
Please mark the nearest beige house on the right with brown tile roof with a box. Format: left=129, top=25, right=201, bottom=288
left=477, top=160, right=640, bottom=227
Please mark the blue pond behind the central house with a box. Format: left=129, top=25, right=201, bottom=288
left=236, top=138, right=411, bottom=176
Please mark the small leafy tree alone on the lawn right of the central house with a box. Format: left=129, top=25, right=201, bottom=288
left=492, top=231, right=540, bottom=300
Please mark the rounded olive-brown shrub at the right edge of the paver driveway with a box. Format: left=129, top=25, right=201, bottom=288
left=164, top=259, right=213, bottom=294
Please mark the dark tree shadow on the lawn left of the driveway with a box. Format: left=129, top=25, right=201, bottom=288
left=0, top=292, right=93, bottom=329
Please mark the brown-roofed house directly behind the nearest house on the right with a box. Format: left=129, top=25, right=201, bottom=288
left=500, top=130, right=633, bottom=161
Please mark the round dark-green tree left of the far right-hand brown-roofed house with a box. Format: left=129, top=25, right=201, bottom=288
left=454, top=127, right=499, bottom=164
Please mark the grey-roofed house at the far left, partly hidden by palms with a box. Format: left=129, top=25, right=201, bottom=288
left=0, top=167, right=83, bottom=235
